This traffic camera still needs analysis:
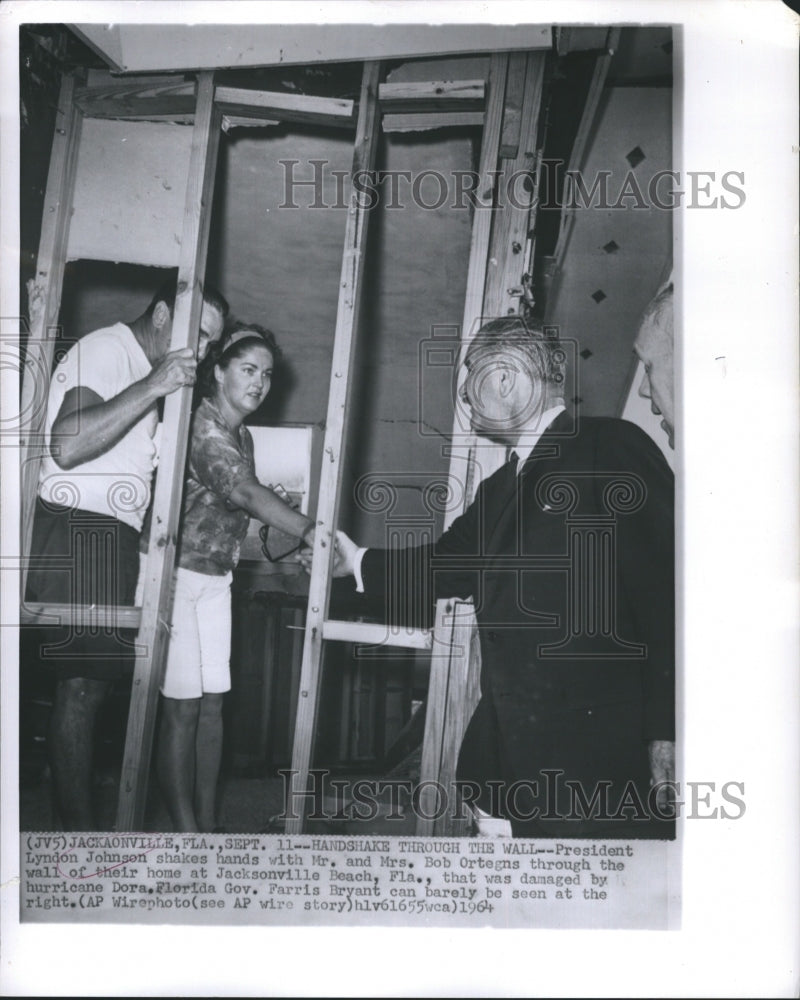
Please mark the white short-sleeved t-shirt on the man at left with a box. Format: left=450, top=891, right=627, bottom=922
left=39, top=323, right=158, bottom=531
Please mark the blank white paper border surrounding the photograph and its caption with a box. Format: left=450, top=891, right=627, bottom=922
left=0, top=0, right=800, bottom=996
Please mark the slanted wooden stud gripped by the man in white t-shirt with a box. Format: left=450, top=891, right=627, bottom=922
left=117, top=73, right=221, bottom=830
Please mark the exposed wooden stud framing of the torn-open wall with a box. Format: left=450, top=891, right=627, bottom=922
left=22, top=53, right=545, bottom=833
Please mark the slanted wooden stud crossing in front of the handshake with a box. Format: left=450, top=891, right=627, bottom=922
left=286, top=63, right=380, bottom=833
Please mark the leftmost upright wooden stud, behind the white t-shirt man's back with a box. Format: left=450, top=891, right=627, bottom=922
left=20, top=76, right=81, bottom=596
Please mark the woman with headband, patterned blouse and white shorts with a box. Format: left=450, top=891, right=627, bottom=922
left=147, top=323, right=314, bottom=832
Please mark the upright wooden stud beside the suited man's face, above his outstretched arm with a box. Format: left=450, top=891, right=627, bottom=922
left=444, top=53, right=508, bottom=528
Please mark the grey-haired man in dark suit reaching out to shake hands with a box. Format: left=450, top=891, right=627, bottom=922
left=336, top=317, right=674, bottom=838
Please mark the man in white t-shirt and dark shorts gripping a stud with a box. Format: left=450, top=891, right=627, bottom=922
left=23, top=277, right=228, bottom=830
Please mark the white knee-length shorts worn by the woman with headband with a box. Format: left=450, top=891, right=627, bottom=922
left=136, top=557, right=233, bottom=699
